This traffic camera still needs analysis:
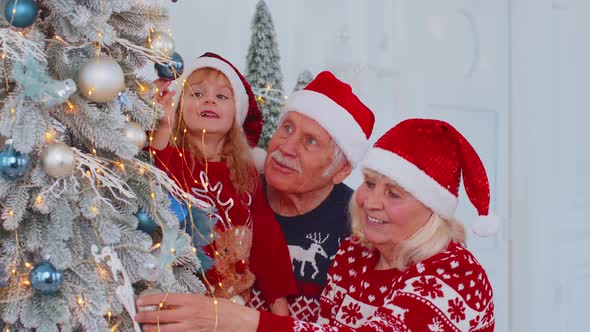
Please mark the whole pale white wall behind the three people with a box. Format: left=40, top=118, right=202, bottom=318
left=149, top=0, right=590, bottom=332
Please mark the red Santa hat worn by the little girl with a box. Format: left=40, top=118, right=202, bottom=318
left=174, top=52, right=266, bottom=170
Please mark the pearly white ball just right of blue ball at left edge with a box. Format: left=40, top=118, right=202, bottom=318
left=41, top=142, right=76, bottom=178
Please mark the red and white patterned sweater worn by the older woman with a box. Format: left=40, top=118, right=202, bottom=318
left=258, top=239, right=494, bottom=332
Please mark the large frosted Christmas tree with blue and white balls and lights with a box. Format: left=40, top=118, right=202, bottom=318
left=0, top=0, right=209, bottom=331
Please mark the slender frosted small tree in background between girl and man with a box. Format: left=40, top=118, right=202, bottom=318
left=245, top=0, right=284, bottom=148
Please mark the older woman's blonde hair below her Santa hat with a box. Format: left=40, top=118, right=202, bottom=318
left=348, top=170, right=466, bottom=271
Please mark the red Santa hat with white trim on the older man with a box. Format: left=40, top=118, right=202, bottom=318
left=281, top=71, right=375, bottom=167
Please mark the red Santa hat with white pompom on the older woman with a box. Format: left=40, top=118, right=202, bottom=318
left=363, top=119, right=499, bottom=237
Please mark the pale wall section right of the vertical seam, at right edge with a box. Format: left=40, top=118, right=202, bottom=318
left=510, top=0, right=590, bottom=332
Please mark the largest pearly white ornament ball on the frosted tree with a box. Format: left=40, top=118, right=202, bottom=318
left=78, top=57, right=125, bottom=103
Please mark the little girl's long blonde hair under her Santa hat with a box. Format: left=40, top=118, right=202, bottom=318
left=171, top=68, right=257, bottom=193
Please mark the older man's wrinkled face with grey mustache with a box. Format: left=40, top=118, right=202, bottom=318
left=264, top=111, right=334, bottom=194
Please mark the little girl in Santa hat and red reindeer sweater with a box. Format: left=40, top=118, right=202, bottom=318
left=150, top=53, right=296, bottom=315
